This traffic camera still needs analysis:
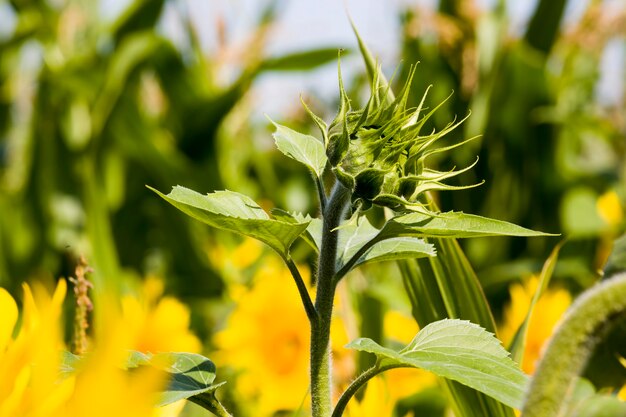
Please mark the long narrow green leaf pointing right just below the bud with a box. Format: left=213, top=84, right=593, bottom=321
left=381, top=211, right=555, bottom=238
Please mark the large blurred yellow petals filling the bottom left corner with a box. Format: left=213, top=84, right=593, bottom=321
left=0, top=280, right=185, bottom=417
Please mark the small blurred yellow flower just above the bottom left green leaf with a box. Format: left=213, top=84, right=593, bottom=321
left=122, top=277, right=202, bottom=353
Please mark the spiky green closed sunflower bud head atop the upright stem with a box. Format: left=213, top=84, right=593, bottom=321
left=306, top=62, right=475, bottom=210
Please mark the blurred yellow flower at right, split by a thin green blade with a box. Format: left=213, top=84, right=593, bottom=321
left=499, top=276, right=572, bottom=373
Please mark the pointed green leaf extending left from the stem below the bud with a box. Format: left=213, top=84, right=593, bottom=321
left=148, top=186, right=309, bottom=258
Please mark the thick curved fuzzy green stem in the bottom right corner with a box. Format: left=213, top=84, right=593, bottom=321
left=522, top=273, right=626, bottom=417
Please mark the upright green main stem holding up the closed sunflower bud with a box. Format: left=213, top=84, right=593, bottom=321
left=310, top=182, right=350, bottom=417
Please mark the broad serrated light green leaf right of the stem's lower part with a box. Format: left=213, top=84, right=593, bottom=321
left=347, top=319, right=528, bottom=408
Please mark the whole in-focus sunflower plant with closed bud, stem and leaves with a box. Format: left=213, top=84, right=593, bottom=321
left=149, top=30, right=560, bottom=417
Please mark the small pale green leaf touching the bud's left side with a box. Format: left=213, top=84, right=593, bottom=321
left=270, top=119, right=328, bottom=178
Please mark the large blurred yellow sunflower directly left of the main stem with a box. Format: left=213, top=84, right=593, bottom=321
left=215, top=258, right=310, bottom=416
